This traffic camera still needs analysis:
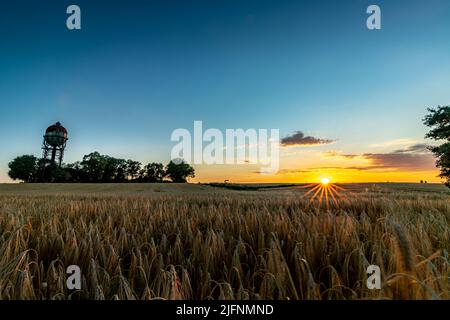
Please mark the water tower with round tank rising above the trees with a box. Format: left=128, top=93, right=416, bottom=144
left=42, top=122, right=68, bottom=166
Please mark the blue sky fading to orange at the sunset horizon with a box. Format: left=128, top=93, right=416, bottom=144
left=0, top=0, right=450, bottom=182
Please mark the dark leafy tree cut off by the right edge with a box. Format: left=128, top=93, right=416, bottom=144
left=423, top=106, right=450, bottom=188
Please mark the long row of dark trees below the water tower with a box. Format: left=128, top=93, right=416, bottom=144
left=8, top=152, right=195, bottom=183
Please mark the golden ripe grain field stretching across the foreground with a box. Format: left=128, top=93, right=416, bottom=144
left=0, top=184, right=450, bottom=300
